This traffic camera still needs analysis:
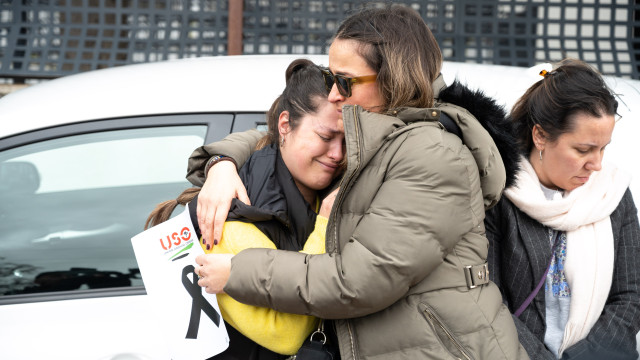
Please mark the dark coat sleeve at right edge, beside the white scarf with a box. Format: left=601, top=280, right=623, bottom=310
left=562, top=189, right=640, bottom=360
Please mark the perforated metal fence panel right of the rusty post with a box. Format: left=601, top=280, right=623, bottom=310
left=244, top=0, right=640, bottom=79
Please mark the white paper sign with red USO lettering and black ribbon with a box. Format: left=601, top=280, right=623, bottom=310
left=131, top=207, right=229, bottom=360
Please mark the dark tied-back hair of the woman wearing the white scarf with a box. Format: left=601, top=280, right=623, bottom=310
left=511, top=59, right=618, bottom=156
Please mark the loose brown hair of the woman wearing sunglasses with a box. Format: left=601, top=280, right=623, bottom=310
left=335, top=4, right=442, bottom=112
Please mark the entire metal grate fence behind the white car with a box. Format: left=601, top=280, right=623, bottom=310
left=0, top=0, right=640, bottom=82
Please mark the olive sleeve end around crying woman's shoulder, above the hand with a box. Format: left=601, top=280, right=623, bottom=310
left=187, top=129, right=264, bottom=186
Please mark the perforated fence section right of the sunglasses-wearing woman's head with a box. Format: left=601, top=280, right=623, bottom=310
left=414, top=0, right=640, bottom=78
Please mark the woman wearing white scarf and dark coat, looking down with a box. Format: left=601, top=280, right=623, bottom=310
left=485, top=61, right=640, bottom=359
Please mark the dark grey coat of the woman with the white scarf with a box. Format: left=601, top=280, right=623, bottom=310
left=485, top=190, right=640, bottom=360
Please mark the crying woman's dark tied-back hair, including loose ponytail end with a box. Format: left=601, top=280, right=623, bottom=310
left=144, top=59, right=329, bottom=230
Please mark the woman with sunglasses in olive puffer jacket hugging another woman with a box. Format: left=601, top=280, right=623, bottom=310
left=189, top=5, right=528, bottom=360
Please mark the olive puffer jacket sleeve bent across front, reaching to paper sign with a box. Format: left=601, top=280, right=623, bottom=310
left=224, top=128, right=486, bottom=319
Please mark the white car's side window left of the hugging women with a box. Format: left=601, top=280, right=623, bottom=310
left=0, top=125, right=207, bottom=296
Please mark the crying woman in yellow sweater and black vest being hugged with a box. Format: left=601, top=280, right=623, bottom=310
left=145, top=59, right=344, bottom=360
